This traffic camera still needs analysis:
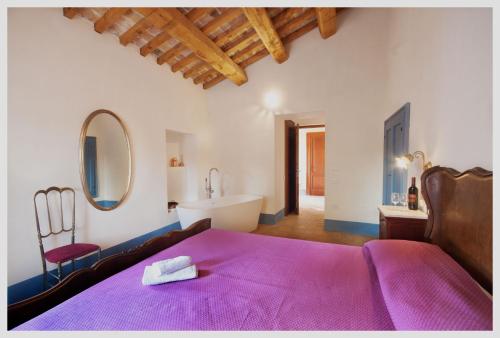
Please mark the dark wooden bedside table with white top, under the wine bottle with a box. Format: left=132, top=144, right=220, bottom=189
left=378, top=205, right=427, bottom=241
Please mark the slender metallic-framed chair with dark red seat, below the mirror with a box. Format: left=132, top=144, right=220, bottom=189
left=33, top=187, right=101, bottom=288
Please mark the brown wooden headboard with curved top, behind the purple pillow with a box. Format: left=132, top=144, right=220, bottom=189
left=421, top=166, right=493, bottom=293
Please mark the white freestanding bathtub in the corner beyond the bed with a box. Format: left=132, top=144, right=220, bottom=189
left=176, top=195, right=262, bottom=232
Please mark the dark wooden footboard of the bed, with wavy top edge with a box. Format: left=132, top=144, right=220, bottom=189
left=7, top=218, right=210, bottom=330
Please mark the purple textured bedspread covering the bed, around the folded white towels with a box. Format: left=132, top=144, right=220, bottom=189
left=16, top=229, right=492, bottom=330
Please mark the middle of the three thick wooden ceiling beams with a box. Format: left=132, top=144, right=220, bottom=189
left=243, top=7, right=288, bottom=63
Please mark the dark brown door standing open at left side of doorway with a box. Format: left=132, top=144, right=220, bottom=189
left=285, top=120, right=299, bottom=215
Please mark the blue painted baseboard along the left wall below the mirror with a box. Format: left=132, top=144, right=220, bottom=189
left=7, top=222, right=182, bottom=304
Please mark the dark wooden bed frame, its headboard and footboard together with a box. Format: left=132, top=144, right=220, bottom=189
left=7, top=166, right=493, bottom=329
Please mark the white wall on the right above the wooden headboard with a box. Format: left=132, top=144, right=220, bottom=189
left=385, top=8, right=493, bottom=187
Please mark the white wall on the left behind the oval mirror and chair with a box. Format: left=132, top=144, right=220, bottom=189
left=8, top=8, right=208, bottom=285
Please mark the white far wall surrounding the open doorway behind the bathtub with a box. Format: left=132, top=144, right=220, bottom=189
left=207, top=9, right=388, bottom=222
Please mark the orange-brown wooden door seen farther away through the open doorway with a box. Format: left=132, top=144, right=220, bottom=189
left=306, top=131, right=325, bottom=196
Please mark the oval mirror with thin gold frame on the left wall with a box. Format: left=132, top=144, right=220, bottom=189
left=80, top=109, right=132, bottom=210
